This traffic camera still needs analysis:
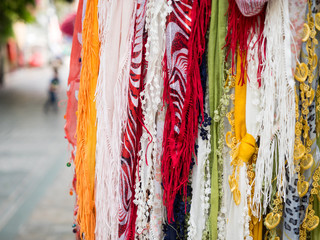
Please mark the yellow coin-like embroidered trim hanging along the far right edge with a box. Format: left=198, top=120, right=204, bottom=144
left=294, top=0, right=320, bottom=240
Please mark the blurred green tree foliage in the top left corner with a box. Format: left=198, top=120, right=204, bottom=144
left=0, top=0, right=35, bottom=44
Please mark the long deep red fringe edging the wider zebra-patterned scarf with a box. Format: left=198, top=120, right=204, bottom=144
left=162, top=0, right=211, bottom=223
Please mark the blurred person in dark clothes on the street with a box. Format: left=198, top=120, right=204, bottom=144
left=44, top=67, right=60, bottom=113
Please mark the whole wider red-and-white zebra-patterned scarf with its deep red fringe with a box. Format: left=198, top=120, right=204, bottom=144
left=162, top=0, right=211, bottom=222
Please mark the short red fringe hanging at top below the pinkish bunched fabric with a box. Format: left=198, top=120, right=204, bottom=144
left=225, top=0, right=265, bottom=85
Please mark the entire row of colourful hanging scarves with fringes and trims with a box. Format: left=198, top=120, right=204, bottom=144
left=65, top=0, right=320, bottom=240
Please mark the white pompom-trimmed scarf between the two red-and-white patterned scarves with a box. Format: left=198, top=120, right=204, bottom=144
left=134, top=0, right=169, bottom=239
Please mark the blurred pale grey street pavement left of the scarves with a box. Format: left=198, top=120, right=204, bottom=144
left=0, top=66, right=75, bottom=240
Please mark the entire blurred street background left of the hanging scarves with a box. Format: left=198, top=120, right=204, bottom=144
left=0, top=0, right=78, bottom=240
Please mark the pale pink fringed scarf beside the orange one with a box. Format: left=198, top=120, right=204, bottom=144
left=96, top=0, right=135, bottom=240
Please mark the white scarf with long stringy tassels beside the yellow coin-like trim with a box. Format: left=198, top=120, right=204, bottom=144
left=253, top=0, right=295, bottom=216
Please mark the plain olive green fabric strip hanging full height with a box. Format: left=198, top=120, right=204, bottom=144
left=208, top=0, right=228, bottom=239
